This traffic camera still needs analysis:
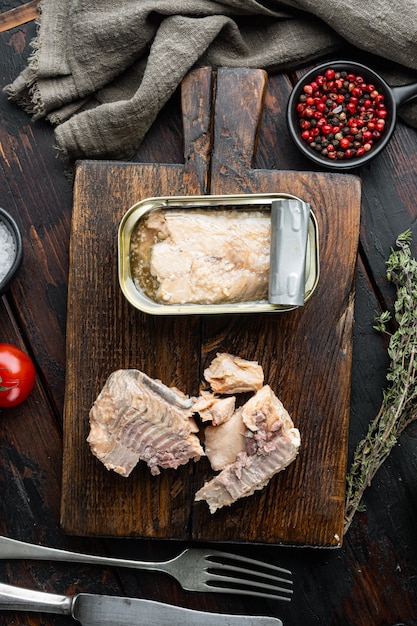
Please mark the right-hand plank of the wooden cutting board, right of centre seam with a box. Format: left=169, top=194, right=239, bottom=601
left=193, top=69, right=360, bottom=545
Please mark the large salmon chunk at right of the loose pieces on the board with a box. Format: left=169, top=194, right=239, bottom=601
left=195, top=385, right=300, bottom=513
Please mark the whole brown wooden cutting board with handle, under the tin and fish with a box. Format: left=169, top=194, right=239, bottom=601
left=61, top=69, right=360, bottom=547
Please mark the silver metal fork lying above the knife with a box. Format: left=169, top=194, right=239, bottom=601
left=0, top=536, right=293, bottom=601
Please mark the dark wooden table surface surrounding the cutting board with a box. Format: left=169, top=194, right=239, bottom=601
left=0, top=0, right=417, bottom=626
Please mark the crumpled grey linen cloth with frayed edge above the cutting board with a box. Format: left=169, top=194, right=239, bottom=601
left=4, top=0, right=417, bottom=162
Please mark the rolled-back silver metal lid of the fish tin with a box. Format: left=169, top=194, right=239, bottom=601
left=268, top=198, right=310, bottom=306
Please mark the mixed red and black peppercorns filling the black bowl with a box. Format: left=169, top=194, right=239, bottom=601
left=296, top=67, right=387, bottom=160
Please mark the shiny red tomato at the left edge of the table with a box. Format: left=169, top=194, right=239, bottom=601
left=0, top=343, right=35, bottom=408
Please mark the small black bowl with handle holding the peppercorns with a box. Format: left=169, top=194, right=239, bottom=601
left=287, top=60, right=417, bottom=171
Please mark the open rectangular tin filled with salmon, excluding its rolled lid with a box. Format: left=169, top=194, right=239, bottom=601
left=118, top=193, right=319, bottom=315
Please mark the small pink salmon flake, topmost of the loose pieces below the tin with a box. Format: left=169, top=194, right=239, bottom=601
left=204, top=353, right=264, bottom=394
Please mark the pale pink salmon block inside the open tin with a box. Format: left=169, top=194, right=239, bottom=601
left=149, top=211, right=271, bottom=304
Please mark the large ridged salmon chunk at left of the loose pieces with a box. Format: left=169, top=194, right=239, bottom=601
left=87, top=369, right=204, bottom=477
